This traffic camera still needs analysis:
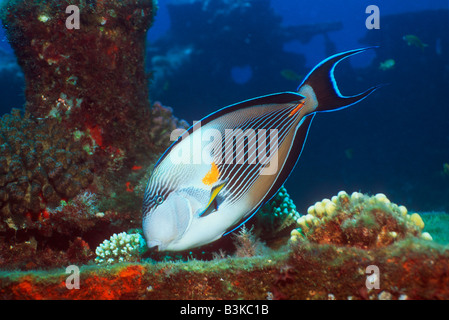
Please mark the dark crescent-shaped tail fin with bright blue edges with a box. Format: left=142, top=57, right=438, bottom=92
left=298, top=47, right=380, bottom=112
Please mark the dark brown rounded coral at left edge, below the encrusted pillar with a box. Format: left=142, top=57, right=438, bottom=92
left=0, top=110, right=93, bottom=229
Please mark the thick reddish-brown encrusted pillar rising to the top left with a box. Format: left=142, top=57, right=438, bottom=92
left=2, top=0, right=155, bottom=154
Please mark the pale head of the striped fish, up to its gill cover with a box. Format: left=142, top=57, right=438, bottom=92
left=143, top=191, right=193, bottom=251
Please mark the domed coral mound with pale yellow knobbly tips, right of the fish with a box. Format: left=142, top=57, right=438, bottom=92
left=290, top=191, right=432, bottom=249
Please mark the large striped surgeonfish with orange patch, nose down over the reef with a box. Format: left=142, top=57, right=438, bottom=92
left=143, top=48, right=378, bottom=251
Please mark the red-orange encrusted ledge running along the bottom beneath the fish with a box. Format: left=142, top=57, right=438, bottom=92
left=0, top=245, right=449, bottom=300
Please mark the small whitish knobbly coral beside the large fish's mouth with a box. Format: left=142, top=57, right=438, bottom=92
left=95, top=232, right=146, bottom=264
